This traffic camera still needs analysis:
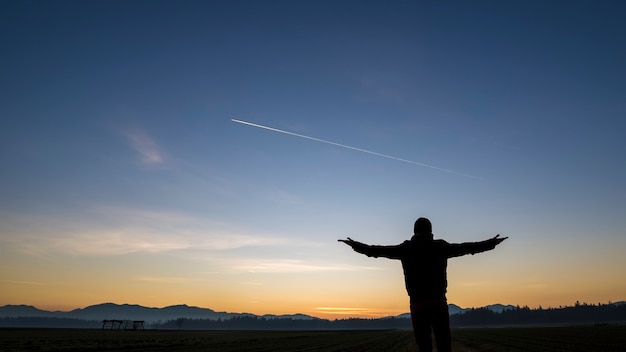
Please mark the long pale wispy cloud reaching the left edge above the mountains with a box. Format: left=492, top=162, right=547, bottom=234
left=0, top=206, right=286, bottom=256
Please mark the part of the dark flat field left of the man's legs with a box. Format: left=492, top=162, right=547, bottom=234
left=0, top=329, right=417, bottom=352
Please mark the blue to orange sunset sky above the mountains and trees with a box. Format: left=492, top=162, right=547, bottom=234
left=0, top=0, right=626, bottom=319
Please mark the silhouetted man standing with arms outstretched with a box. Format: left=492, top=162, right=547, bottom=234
left=339, top=218, right=508, bottom=352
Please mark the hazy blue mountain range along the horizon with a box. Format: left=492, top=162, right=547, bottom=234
left=0, top=303, right=515, bottom=324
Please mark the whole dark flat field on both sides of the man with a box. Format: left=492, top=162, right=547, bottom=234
left=0, top=325, right=626, bottom=352
